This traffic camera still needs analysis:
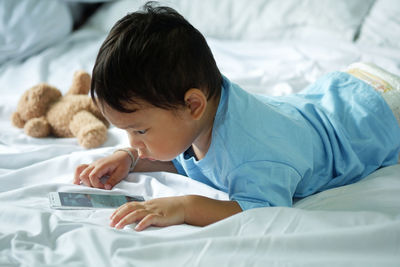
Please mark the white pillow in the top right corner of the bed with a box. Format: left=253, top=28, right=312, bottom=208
left=358, top=0, right=400, bottom=48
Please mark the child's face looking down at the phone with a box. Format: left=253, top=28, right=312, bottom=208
left=103, top=104, right=196, bottom=161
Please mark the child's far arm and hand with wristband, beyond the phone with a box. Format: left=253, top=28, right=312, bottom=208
left=74, top=149, right=177, bottom=189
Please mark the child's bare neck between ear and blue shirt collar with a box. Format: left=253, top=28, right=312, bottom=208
left=192, top=94, right=220, bottom=160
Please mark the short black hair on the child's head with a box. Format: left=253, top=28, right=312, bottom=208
left=91, top=2, right=222, bottom=113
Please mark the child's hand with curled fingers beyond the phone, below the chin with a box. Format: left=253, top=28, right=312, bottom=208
left=74, top=151, right=132, bottom=190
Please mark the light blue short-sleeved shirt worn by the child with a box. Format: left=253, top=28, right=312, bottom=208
left=173, top=72, right=400, bottom=210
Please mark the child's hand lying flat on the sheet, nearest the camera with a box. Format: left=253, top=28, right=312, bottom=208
left=110, top=197, right=185, bottom=231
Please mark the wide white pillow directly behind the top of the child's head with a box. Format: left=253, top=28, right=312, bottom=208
left=85, top=0, right=374, bottom=41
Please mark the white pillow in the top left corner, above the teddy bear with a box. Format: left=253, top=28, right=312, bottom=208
left=0, top=0, right=72, bottom=64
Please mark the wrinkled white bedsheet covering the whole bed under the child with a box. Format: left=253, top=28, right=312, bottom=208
left=0, top=1, right=400, bottom=267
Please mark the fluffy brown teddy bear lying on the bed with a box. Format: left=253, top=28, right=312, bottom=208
left=11, top=71, right=109, bottom=148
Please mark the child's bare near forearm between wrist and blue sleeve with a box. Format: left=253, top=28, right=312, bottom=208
left=183, top=195, right=242, bottom=226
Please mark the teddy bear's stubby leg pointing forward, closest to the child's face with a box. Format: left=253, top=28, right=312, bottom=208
left=69, top=110, right=107, bottom=148
